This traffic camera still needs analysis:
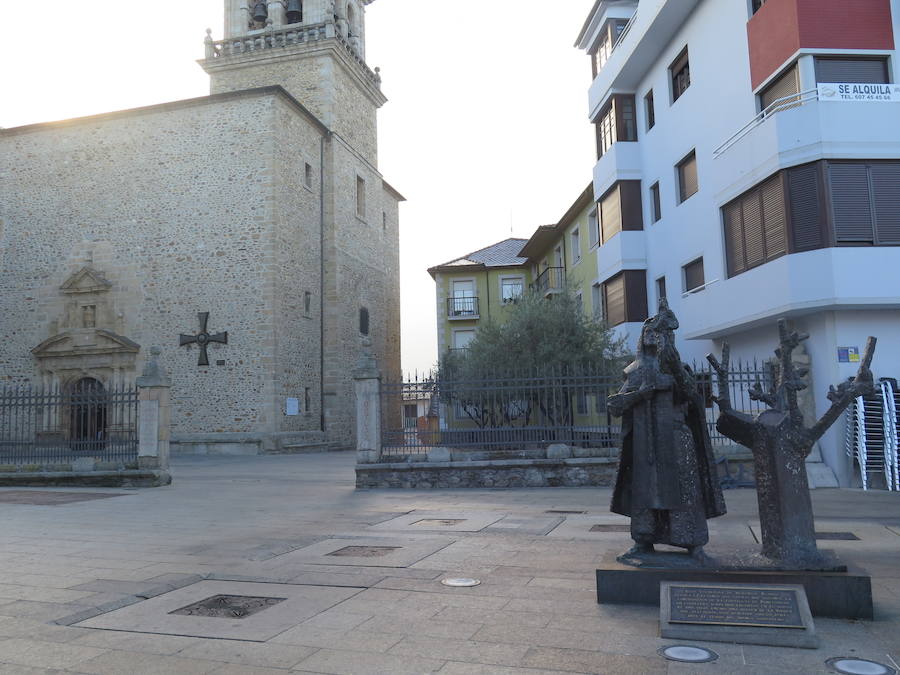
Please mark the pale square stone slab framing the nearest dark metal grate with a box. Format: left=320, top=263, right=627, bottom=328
left=76, top=581, right=360, bottom=641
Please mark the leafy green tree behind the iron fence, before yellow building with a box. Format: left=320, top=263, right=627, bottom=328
left=438, top=290, right=627, bottom=427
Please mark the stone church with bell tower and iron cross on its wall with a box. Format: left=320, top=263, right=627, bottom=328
left=0, top=0, right=403, bottom=453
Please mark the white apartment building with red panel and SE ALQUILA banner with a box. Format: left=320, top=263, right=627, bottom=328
left=576, top=0, right=900, bottom=486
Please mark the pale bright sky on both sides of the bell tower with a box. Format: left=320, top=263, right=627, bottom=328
left=0, top=0, right=594, bottom=371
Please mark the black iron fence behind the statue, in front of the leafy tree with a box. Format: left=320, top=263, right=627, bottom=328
left=381, top=363, right=772, bottom=457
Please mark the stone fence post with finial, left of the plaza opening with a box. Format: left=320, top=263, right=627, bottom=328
left=137, top=347, right=171, bottom=470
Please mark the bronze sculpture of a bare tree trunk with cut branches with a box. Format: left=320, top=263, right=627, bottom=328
left=706, top=319, right=875, bottom=569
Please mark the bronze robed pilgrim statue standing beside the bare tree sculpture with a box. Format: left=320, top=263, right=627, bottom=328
left=608, top=299, right=725, bottom=564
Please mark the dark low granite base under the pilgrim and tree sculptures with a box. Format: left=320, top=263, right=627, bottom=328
left=597, top=554, right=874, bottom=619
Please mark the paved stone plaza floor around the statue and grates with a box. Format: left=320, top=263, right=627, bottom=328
left=0, top=453, right=900, bottom=675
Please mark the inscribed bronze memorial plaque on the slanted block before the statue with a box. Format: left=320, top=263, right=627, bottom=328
left=669, top=584, right=804, bottom=629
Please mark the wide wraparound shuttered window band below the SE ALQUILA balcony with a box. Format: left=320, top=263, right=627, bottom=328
left=722, top=160, right=900, bottom=276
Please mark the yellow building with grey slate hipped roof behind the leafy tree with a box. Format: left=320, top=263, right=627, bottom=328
left=428, top=238, right=533, bottom=356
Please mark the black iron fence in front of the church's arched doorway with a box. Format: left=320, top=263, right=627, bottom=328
left=0, top=379, right=138, bottom=466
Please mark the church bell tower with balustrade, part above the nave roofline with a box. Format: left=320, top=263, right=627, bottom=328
left=200, top=0, right=387, bottom=166
